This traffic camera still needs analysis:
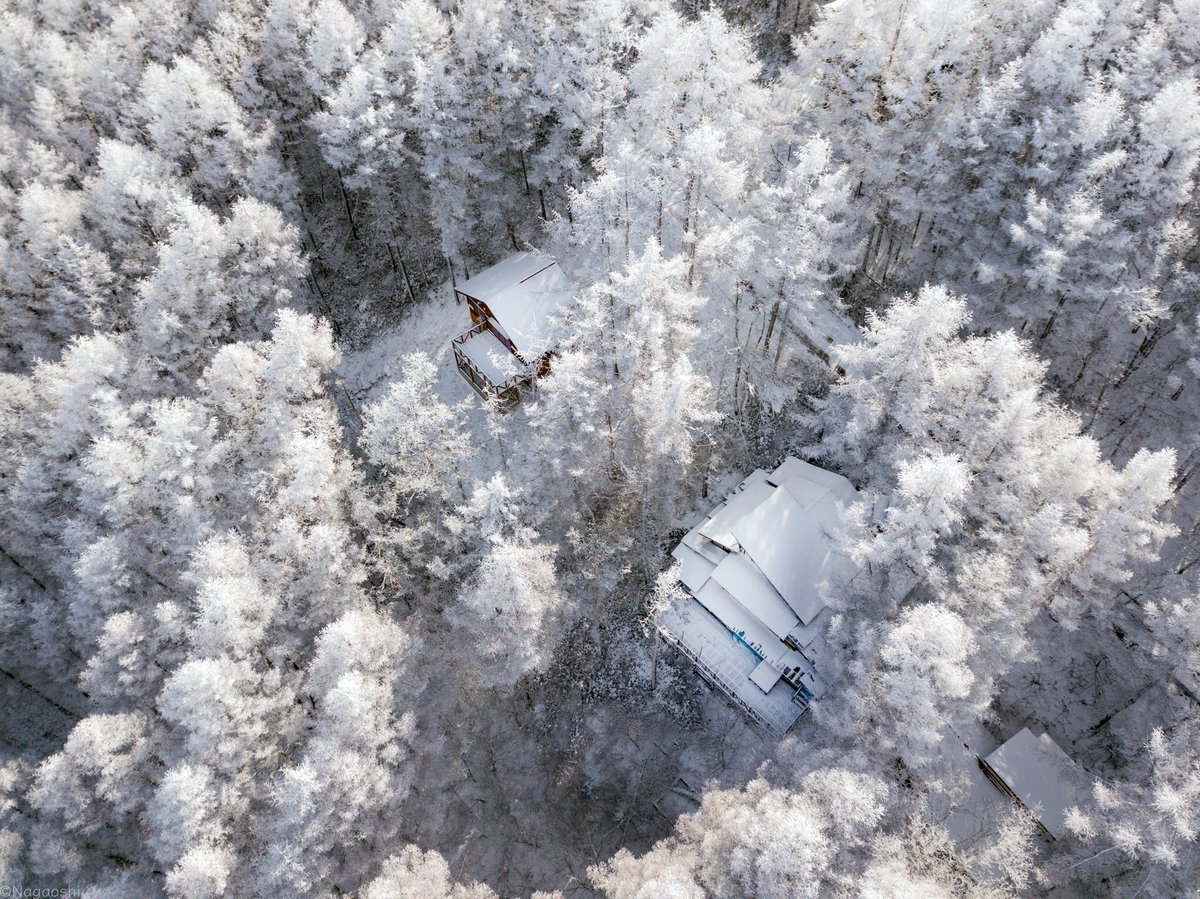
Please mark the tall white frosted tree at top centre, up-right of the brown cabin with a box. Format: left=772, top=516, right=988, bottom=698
left=561, top=12, right=767, bottom=286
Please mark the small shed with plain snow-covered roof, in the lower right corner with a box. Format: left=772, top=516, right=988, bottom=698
left=979, top=727, right=1091, bottom=839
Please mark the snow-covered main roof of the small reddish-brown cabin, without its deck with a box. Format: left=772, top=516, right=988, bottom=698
left=456, top=253, right=575, bottom=360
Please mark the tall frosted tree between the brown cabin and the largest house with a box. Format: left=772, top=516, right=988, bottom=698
left=535, top=241, right=719, bottom=547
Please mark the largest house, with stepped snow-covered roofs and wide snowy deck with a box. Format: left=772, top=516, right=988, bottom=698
left=658, top=457, right=858, bottom=733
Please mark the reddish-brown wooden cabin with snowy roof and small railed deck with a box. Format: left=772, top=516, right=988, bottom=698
left=451, top=252, right=575, bottom=406
